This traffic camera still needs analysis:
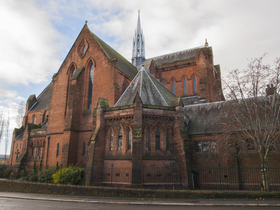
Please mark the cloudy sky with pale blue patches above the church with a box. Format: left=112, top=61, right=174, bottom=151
left=0, top=0, right=280, bottom=154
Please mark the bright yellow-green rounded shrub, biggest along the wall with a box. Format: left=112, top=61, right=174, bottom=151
left=52, top=165, right=84, bottom=185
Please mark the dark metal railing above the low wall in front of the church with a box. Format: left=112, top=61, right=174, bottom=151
left=0, top=165, right=280, bottom=191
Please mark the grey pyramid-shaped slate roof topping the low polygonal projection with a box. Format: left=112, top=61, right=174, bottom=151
left=114, top=67, right=177, bottom=107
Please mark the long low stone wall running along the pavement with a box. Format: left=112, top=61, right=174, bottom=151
left=0, top=179, right=280, bottom=198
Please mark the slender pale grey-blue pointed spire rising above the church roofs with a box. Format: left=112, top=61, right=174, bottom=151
left=131, top=10, right=145, bottom=66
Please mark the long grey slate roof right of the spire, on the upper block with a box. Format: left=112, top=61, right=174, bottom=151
left=138, top=46, right=205, bottom=71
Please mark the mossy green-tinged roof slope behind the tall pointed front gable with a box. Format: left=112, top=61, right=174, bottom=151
left=90, top=28, right=138, bottom=79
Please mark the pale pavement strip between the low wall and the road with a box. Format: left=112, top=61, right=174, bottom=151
left=0, top=192, right=280, bottom=207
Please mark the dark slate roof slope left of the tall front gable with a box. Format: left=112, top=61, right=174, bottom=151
left=29, top=82, right=53, bottom=111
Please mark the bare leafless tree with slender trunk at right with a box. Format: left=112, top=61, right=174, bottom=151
left=217, top=55, right=280, bottom=190
